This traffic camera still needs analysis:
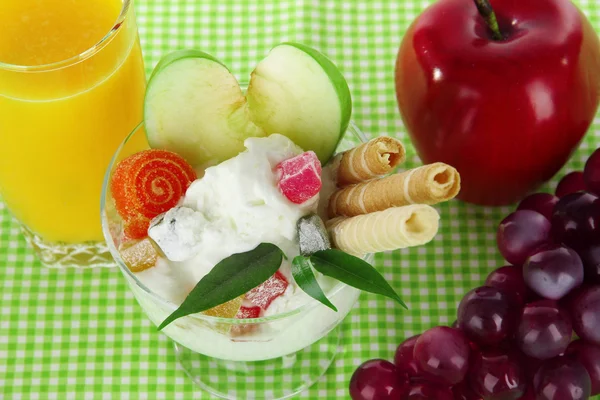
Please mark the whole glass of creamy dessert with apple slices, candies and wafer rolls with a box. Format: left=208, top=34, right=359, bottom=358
left=102, top=44, right=460, bottom=398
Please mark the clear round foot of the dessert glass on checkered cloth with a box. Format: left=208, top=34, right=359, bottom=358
left=174, top=324, right=343, bottom=400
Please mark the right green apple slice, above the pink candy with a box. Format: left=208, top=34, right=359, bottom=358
left=246, top=43, right=352, bottom=163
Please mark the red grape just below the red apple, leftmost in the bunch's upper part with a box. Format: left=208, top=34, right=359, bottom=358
left=496, top=210, right=551, bottom=265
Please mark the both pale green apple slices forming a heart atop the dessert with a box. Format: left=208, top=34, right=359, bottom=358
left=144, top=43, right=352, bottom=166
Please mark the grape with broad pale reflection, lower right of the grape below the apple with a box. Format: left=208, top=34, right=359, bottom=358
left=523, top=245, right=583, bottom=300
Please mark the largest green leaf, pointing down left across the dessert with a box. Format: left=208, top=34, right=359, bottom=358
left=158, top=243, right=283, bottom=330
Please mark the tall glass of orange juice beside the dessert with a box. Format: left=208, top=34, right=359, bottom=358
left=0, top=0, right=147, bottom=266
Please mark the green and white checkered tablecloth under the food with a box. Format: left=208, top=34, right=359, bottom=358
left=0, top=0, right=600, bottom=400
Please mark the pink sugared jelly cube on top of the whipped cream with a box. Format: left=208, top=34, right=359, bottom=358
left=276, top=151, right=321, bottom=204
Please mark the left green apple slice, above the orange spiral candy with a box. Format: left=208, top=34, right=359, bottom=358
left=144, top=50, right=266, bottom=166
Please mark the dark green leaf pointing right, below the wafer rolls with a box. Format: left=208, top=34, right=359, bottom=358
left=310, top=249, right=407, bottom=308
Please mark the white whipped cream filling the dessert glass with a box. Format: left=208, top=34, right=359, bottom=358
left=126, top=135, right=360, bottom=361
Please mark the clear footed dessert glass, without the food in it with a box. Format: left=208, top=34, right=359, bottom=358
left=101, top=122, right=372, bottom=399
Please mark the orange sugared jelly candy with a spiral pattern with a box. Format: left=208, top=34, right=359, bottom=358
left=110, top=149, right=196, bottom=239
